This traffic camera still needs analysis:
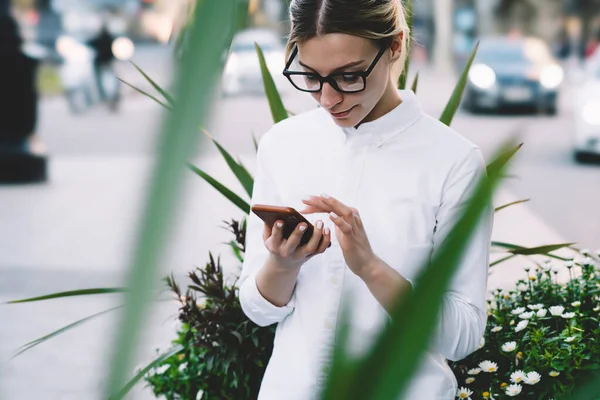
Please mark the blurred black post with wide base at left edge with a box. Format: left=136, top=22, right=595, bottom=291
left=0, top=0, right=47, bottom=183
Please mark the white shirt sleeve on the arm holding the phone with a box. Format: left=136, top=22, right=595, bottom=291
left=239, top=134, right=295, bottom=326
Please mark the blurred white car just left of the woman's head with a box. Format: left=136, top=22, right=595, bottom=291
left=222, top=29, right=289, bottom=96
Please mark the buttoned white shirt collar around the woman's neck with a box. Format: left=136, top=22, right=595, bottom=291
left=342, top=90, right=423, bottom=147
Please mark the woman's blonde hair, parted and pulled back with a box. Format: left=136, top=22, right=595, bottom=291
left=286, top=0, right=410, bottom=76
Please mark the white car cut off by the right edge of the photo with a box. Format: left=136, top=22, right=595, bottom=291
left=573, top=51, right=600, bottom=162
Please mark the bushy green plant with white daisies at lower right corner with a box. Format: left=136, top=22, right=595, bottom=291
left=450, top=251, right=600, bottom=400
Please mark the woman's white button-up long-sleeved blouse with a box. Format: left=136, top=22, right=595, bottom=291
left=239, top=91, right=493, bottom=400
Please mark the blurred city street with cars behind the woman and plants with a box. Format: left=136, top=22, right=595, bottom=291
left=0, top=0, right=600, bottom=400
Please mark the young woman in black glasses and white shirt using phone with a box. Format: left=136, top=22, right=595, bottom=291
left=240, top=0, right=493, bottom=400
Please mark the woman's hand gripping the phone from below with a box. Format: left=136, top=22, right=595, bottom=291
left=263, top=220, right=331, bottom=268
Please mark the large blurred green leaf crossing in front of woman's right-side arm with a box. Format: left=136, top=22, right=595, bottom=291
left=323, top=138, right=514, bottom=400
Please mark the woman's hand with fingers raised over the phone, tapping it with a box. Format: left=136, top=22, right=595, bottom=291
left=300, top=195, right=377, bottom=277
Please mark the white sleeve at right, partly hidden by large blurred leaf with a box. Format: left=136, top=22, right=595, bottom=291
left=432, top=148, right=494, bottom=361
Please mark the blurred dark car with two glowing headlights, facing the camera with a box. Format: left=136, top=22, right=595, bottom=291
left=463, top=37, right=564, bottom=114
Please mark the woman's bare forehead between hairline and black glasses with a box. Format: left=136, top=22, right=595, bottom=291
left=298, top=33, right=376, bottom=74
